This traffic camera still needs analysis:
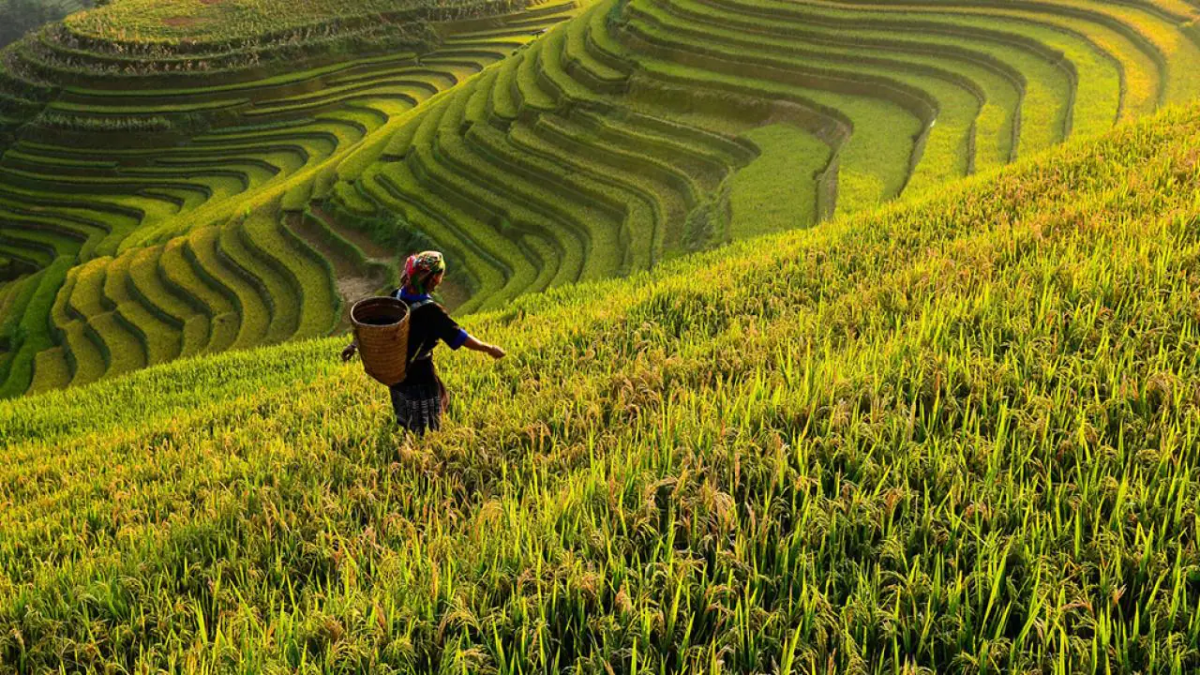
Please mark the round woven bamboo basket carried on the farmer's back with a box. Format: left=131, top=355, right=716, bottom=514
left=350, top=298, right=409, bottom=387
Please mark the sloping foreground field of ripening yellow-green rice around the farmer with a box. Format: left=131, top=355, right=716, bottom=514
left=0, top=107, right=1200, bottom=673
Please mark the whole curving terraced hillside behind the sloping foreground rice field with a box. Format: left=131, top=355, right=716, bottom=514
left=0, top=0, right=1200, bottom=395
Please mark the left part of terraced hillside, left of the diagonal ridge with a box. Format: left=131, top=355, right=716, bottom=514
left=0, top=0, right=570, bottom=395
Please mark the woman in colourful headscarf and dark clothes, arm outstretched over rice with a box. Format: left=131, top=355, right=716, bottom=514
left=342, top=251, right=504, bottom=435
